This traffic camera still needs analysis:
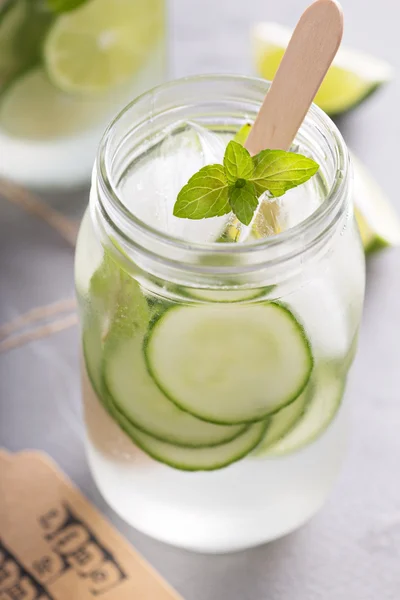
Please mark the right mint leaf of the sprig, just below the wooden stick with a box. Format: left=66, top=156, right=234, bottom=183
left=250, top=150, right=319, bottom=197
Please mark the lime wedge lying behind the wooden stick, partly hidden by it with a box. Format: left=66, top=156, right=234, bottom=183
left=252, top=23, right=393, bottom=115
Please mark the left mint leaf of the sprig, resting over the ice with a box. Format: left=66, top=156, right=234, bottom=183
left=174, top=165, right=231, bottom=219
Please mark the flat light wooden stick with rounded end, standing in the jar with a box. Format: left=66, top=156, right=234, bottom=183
left=245, top=0, right=343, bottom=155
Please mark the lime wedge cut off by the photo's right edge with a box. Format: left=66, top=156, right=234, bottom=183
left=352, top=155, right=400, bottom=252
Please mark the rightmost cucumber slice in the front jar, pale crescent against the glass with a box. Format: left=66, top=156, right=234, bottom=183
left=264, top=368, right=345, bottom=456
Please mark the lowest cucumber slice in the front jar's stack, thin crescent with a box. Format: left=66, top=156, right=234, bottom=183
left=110, top=410, right=268, bottom=471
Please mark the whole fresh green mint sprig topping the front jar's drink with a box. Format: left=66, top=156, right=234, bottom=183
left=174, top=131, right=319, bottom=225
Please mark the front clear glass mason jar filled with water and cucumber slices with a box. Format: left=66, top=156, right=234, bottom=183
left=75, top=76, right=364, bottom=552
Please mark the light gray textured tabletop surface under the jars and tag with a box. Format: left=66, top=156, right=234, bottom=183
left=0, top=0, right=400, bottom=600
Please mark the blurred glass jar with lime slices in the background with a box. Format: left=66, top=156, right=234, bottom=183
left=0, top=0, right=166, bottom=188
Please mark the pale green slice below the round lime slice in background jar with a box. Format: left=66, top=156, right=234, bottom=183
left=0, top=68, right=111, bottom=140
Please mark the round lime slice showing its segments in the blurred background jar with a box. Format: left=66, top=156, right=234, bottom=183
left=44, top=0, right=164, bottom=94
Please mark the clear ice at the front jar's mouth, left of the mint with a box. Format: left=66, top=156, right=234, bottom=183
left=122, top=121, right=229, bottom=242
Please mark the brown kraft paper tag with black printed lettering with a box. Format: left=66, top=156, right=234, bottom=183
left=0, top=449, right=182, bottom=600
